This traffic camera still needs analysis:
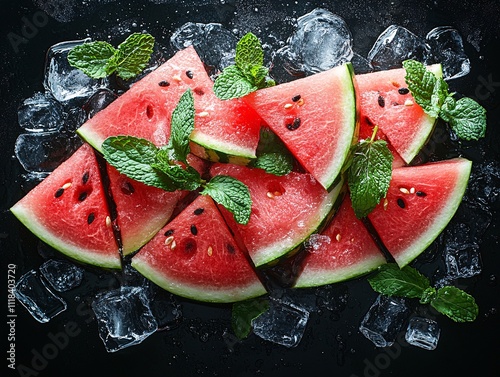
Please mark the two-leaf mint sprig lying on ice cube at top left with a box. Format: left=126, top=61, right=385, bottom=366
left=68, top=33, right=155, bottom=80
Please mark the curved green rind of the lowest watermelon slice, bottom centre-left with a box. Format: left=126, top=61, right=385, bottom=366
left=131, top=253, right=267, bottom=303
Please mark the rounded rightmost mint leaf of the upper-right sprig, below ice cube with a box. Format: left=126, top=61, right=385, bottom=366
left=439, top=97, right=486, bottom=140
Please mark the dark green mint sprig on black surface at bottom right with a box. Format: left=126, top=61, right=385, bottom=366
left=368, top=263, right=479, bottom=322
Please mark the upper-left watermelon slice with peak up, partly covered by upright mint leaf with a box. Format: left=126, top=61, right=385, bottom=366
left=77, top=46, right=262, bottom=162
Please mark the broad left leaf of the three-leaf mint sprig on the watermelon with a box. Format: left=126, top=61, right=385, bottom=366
left=102, top=136, right=177, bottom=191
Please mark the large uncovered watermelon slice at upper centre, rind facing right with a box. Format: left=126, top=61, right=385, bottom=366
left=243, top=64, right=356, bottom=189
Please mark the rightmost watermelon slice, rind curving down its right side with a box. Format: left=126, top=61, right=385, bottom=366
left=368, top=158, right=472, bottom=266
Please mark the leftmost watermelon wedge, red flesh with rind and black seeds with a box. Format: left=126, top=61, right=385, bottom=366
left=11, top=144, right=121, bottom=268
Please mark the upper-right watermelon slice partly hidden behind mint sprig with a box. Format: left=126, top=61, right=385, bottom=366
left=355, top=64, right=442, bottom=166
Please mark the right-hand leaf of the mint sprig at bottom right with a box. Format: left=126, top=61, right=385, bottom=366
left=431, top=286, right=479, bottom=322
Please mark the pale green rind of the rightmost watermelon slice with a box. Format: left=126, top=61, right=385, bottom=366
left=389, top=158, right=472, bottom=267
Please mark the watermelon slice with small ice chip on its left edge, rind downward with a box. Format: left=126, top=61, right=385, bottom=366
left=295, top=196, right=385, bottom=288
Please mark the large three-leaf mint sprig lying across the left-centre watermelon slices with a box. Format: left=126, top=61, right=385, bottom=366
left=102, top=89, right=252, bottom=224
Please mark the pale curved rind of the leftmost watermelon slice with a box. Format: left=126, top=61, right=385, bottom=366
left=10, top=202, right=121, bottom=269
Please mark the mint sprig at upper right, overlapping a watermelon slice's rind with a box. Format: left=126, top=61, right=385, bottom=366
left=403, top=60, right=486, bottom=140
